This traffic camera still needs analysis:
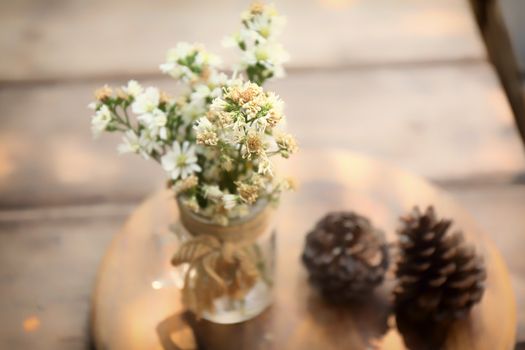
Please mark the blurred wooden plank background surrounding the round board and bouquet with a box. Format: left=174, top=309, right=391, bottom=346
left=0, top=0, right=525, bottom=349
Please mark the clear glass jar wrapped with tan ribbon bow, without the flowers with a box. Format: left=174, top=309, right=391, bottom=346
left=172, top=201, right=276, bottom=324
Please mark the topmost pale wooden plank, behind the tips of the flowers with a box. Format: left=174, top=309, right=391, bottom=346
left=0, top=0, right=485, bottom=81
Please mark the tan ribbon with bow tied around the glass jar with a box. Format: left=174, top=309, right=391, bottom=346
left=171, top=200, right=270, bottom=316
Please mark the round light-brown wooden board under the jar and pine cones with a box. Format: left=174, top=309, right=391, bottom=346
left=92, top=151, right=516, bottom=350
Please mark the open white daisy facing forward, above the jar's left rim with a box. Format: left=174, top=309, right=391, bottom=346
left=161, top=141, right=201, bottom=180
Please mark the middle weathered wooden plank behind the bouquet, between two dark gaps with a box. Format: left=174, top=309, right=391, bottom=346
left=0, top=63, right=525, bottom=207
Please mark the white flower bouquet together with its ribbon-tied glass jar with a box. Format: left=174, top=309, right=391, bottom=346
left=90, top=3, right=297, bottom=323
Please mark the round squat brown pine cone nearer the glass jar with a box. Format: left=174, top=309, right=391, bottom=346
left=302, top=212, right=388, bottom=302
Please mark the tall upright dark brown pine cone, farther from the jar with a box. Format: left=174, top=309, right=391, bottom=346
left=394, top=207, right=486, bottom=321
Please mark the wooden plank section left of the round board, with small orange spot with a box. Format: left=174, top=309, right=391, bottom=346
left=0, top=211, right=127, bottom=350
